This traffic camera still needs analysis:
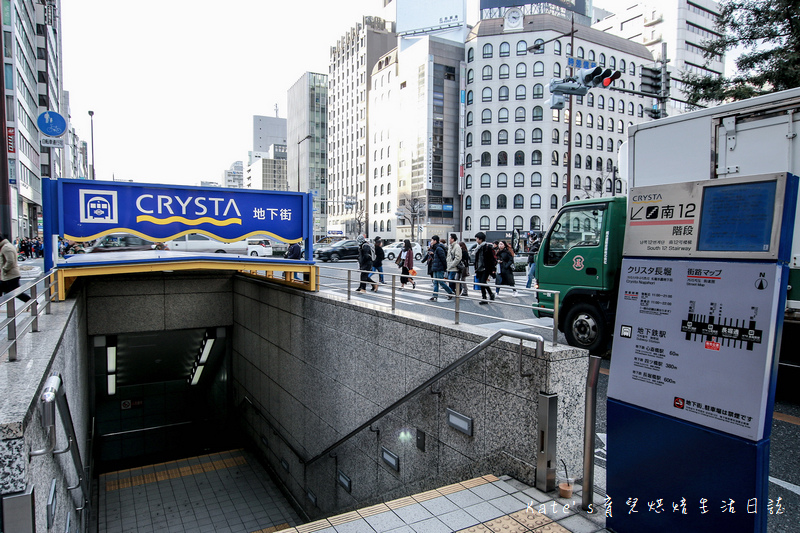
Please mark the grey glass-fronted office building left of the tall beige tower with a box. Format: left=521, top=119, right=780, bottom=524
left=286, top=72, right=328, bottom=241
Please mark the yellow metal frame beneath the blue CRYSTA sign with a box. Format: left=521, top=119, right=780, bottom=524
left=56, top=260, right=319, bottom=301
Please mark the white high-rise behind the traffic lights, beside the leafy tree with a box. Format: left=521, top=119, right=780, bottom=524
left=592, top=0, right=725, bottom=115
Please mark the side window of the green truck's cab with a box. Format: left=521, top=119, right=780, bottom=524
left=544, top=205, right=605, bottom=265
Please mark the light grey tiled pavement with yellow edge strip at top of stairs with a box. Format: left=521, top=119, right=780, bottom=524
left=282, top=476, right=605, bottom=533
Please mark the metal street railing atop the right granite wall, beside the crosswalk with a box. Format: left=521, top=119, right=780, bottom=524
left=318, top=265, right=561, bottom=346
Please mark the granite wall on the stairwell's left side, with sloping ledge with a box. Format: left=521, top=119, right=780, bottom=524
left=0, top=296, right=90, bottom=532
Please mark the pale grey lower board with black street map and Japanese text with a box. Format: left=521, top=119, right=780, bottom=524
left=608, top=258, right=783, bottom=441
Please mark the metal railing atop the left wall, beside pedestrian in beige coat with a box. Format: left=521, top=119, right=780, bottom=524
left=0, top=269, right=58, bottom=361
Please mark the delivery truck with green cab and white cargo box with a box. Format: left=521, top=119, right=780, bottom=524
left=534, top=89, right=800, bottom=371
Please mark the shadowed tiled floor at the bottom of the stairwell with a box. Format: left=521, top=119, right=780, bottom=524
left=98, top=450, right=300, bottom=533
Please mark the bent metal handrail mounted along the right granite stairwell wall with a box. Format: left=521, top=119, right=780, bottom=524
left=239, top=329, right=544, bottom=466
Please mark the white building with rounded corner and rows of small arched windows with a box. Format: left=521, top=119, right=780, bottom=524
left=464, top=9, right=652, bottom=237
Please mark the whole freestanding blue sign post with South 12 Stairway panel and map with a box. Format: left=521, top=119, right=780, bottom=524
left=606, top=174, right=798, bottom=533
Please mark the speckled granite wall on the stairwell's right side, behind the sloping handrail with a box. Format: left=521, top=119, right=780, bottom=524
left=233, top=277, right=588, bottom=517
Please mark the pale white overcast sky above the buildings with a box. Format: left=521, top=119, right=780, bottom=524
left=61, top=0, right=688, bottom=185
